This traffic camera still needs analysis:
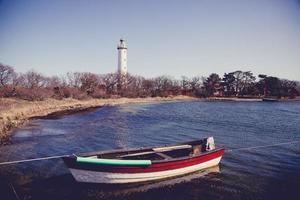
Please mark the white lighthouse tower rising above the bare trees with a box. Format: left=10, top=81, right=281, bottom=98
left=118, top=38, right=127, bottom=76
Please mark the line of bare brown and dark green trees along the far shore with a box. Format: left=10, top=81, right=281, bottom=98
left=0, top=63, right=300, bottom=100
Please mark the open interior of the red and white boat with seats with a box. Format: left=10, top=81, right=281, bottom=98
left=89, top=139, right=215, bottom=160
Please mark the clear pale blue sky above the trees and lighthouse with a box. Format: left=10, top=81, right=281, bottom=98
left=0, top=0, right=300, bottom=81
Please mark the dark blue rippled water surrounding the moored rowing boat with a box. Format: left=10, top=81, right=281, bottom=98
left=0, top=102, right=300, bottom=200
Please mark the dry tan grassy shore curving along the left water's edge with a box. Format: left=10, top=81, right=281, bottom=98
left=0, top=96, right=196, bottom=144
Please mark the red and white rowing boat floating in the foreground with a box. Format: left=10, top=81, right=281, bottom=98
left=63, top=137, right=224, bottom=184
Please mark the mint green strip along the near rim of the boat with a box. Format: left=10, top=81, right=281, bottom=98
left=76, top=157, right=151, bottom=166
